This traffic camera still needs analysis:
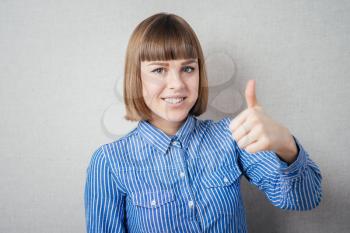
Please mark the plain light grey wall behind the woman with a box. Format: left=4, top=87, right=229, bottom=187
left=0, top=0, right=350, bottom=233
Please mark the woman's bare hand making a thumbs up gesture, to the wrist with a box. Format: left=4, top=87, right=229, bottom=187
left=230, top=80, right=298, bottom=164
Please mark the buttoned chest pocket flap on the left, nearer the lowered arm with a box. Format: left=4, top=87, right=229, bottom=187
left=132, top=190, right=175, bottom=208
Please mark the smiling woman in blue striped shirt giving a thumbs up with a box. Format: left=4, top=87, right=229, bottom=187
left=84, top=13, right=322, bottom=232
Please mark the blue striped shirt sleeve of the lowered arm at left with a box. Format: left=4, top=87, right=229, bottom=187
left=84, top=146, right=125, bottom=233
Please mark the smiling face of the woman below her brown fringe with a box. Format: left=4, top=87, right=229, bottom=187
left=141, top=59, right=199, bottom=130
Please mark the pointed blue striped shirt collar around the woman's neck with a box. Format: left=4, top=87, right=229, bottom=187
left=137, top=114, right=196, bottom=154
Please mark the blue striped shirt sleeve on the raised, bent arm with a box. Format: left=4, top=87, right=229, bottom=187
left=220, top=118, right=322, bottom=211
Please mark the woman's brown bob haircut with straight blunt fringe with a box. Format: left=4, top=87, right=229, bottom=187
left=124, top=13, right=208, bottom=121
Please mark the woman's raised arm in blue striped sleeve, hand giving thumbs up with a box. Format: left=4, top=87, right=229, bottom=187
left=229, top=80, right=322, bottom=210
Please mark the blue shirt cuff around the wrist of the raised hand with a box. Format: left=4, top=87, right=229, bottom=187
left=276, top=135, right=307, bottom=179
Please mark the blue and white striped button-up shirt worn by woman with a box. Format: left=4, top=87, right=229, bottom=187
left=84, top=115, right=322, bottom=233
